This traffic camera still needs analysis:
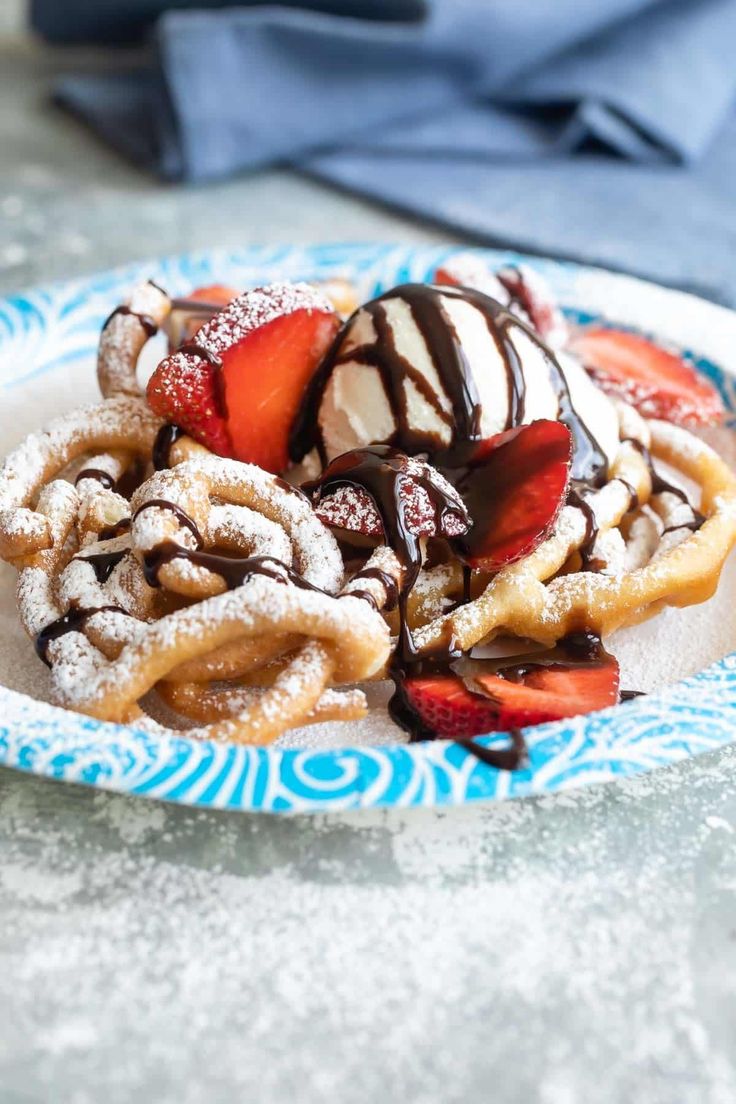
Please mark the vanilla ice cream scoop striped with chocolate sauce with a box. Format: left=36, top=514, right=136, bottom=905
left=292, top=284, right=618, bottom=482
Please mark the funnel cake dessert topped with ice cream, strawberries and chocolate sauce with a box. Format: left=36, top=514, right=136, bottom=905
left=0, top=256, right=736, bottom=767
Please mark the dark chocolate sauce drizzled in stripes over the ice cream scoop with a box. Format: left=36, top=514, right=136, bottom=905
left=289, top=284, right=608, bottom=486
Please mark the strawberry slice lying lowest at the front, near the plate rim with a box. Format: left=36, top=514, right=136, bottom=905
left=404, top=656, right=619, bottom=740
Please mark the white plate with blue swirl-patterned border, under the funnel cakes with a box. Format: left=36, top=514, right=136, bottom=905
left=0, top=245, right=736, bottom=813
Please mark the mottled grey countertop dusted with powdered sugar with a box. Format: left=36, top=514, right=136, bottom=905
left=0, top=38, right=736, bottom=1104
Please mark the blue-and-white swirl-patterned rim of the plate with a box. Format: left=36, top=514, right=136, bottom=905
left=0, top=242, right=736, bottom=813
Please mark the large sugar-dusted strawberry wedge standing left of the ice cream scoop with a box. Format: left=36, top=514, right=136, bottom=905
left=148, top=284, right=340, bottom=471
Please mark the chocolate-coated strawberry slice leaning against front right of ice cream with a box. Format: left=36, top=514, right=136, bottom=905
left=455, top=421, right=573, bottom=571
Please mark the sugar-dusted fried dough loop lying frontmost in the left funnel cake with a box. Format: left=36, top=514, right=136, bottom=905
left=52, top=575, right=390, bottom=743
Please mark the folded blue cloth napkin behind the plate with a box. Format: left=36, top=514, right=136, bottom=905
left=53, top=0, right=736, bottom=301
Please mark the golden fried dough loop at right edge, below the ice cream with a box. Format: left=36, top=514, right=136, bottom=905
left=415, top=416, right=736, bottom=650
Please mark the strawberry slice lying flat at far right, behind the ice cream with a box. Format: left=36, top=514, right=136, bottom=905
left=572, top=327, right=724, bottom=425
